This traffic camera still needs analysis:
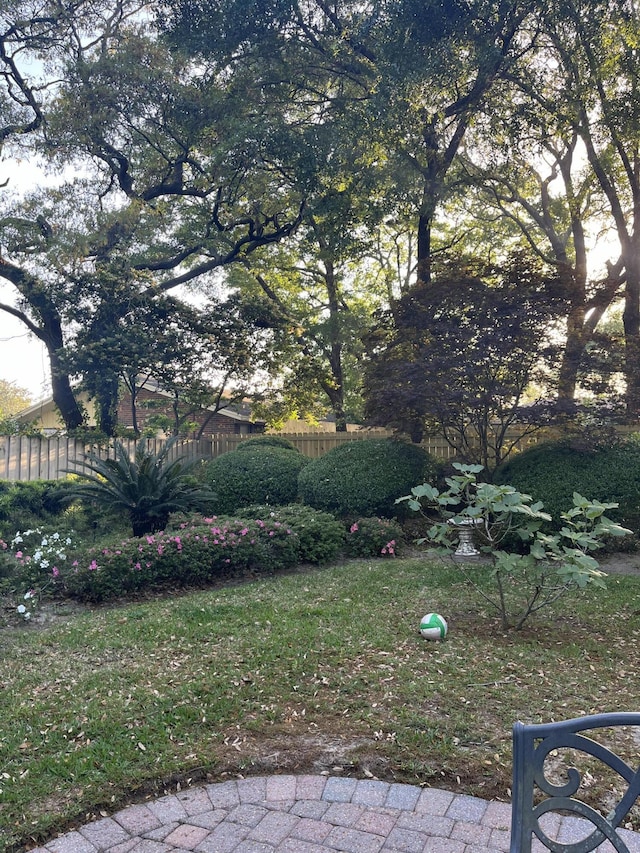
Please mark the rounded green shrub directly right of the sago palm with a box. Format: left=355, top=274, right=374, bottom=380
left=203, top=447, right=309, bottom=514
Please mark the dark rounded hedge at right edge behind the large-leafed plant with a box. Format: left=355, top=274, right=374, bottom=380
left=494, top=441, right=640, bottom=532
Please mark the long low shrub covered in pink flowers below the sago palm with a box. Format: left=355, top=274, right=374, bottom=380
left=62, top=517, right=298, bottom=602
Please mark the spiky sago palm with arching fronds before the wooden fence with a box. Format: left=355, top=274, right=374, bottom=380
left=67, top=439, right=214, bottom=536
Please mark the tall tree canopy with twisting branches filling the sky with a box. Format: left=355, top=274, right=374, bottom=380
left=0, top=5, right=640, bottom=446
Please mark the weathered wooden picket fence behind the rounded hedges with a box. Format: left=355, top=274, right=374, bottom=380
left=0, top=429, right=535, bottom=480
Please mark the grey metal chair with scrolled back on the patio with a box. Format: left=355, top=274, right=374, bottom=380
left=510, top=713, right=640, bottom=853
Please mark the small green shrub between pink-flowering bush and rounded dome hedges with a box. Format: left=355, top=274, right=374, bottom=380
left=242, top=504, right=345, bottom=563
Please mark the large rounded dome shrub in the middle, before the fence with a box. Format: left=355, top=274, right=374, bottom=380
left=298, top=438, right=436, bottom=518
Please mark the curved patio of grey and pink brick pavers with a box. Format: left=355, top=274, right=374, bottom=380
left=32, top=775, right=640, bottom=853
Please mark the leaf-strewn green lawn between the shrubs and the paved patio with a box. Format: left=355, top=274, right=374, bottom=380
left=0, top=559, right=640, bottom=851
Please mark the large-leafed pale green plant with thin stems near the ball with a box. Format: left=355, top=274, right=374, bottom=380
left=398, top=463, right=631, bottom=629
